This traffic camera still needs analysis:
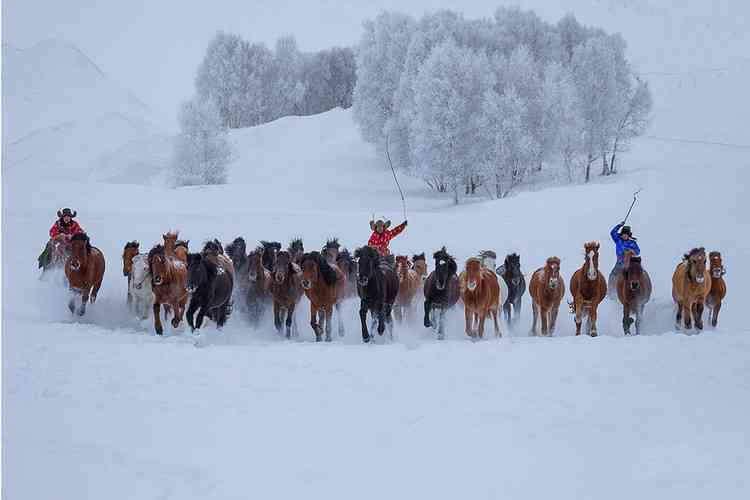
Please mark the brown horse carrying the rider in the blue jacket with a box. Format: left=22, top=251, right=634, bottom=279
left=616, top=254, right=652, bottom=335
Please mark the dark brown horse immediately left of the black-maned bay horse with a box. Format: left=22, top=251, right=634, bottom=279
left=271, top=250, right=302, bottom=338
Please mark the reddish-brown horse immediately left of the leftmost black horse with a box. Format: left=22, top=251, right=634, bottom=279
left=148, top=245, right=188, bottom=335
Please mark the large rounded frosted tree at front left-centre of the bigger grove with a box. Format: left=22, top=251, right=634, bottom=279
left=411, top=40, right=493, bottom=203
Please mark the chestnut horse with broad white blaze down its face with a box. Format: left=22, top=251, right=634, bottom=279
left=570, top=241, right=607, bottom=337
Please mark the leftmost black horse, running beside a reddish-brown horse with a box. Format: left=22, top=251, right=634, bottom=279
left=186, top=253, right=233, bottom=331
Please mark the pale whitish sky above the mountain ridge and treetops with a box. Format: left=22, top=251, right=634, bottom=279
left=2, top=0, right=750, bottom=129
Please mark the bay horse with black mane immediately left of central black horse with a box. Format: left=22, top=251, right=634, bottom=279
left=301, top=252, right=345, bottom=342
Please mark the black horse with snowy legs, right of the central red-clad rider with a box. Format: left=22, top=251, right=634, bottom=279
left=424, top=247, right=459, bottom=340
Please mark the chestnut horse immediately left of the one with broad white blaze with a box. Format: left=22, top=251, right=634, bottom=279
left=529, top=257, right=565, bottom=337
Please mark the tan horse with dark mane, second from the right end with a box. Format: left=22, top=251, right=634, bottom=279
left=672, top=247, right=711, bottom=330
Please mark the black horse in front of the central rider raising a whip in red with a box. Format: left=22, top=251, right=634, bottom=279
left=354, top=246, right=398, bottom=343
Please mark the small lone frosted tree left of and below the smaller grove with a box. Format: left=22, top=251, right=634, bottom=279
left=172, top=99, right=232, bottom=186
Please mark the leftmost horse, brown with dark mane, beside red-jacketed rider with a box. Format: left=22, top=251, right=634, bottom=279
left=65, top=233, right=105, bottom=316
